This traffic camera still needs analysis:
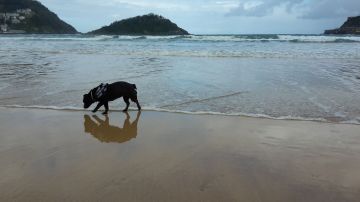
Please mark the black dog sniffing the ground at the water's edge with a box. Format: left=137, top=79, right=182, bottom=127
left=83, top=81, right=141, bottom=114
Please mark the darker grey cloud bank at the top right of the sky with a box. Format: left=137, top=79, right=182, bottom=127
left=226, top=0, right=360, bottom=19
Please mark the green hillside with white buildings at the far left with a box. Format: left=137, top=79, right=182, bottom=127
left=0, top=0, right=78, bottom=34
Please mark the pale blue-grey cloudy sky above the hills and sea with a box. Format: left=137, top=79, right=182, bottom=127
left=39, top=0, right=360, bottom=34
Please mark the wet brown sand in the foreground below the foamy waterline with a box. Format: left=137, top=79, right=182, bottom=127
left=0, top=108, right=360, bottom=202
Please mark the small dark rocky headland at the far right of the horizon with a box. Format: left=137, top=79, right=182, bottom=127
left=324, top=16, right=360, bottom=35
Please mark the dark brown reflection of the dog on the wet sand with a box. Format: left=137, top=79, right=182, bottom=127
left=84, top=111, right=141, bottom=143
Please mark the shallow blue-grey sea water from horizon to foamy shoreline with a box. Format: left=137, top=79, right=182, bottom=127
left=0, top=35, right=360, bottom=124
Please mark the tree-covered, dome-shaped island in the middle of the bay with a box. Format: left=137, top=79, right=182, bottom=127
left=88, top=13, right=189, bottom=35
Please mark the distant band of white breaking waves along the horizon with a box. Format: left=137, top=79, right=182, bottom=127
left=0, top=34, right=360, bottom=43
